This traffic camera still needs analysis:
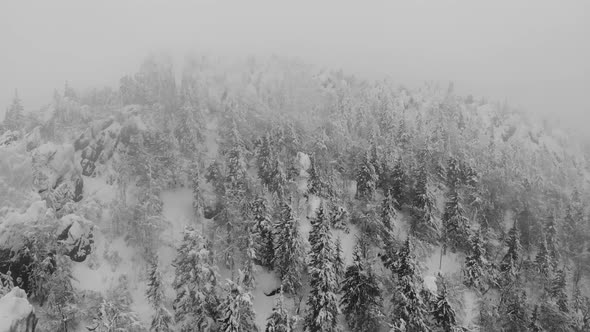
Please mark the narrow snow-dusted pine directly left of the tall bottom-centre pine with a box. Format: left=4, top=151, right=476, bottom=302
left=273, top=201, right=304, bottom=294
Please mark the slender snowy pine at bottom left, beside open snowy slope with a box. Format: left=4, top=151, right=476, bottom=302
left=146, top=258, right=173, bottom=332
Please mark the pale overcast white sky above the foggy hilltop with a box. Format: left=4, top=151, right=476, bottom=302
left=0, top=0, right=590, bottom=128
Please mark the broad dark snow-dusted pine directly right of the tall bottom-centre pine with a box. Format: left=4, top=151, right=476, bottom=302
left=340, top=238, right=383, bottom=332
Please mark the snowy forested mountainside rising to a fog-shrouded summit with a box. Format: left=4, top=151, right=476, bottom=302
left=0, top=56, right=590, bottom=331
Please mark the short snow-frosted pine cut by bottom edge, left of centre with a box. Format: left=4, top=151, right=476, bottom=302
left=218, top=280, right=258, bottom=332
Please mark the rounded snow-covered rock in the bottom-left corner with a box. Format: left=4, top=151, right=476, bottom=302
left=0, top=287, right=37, bottom=332
